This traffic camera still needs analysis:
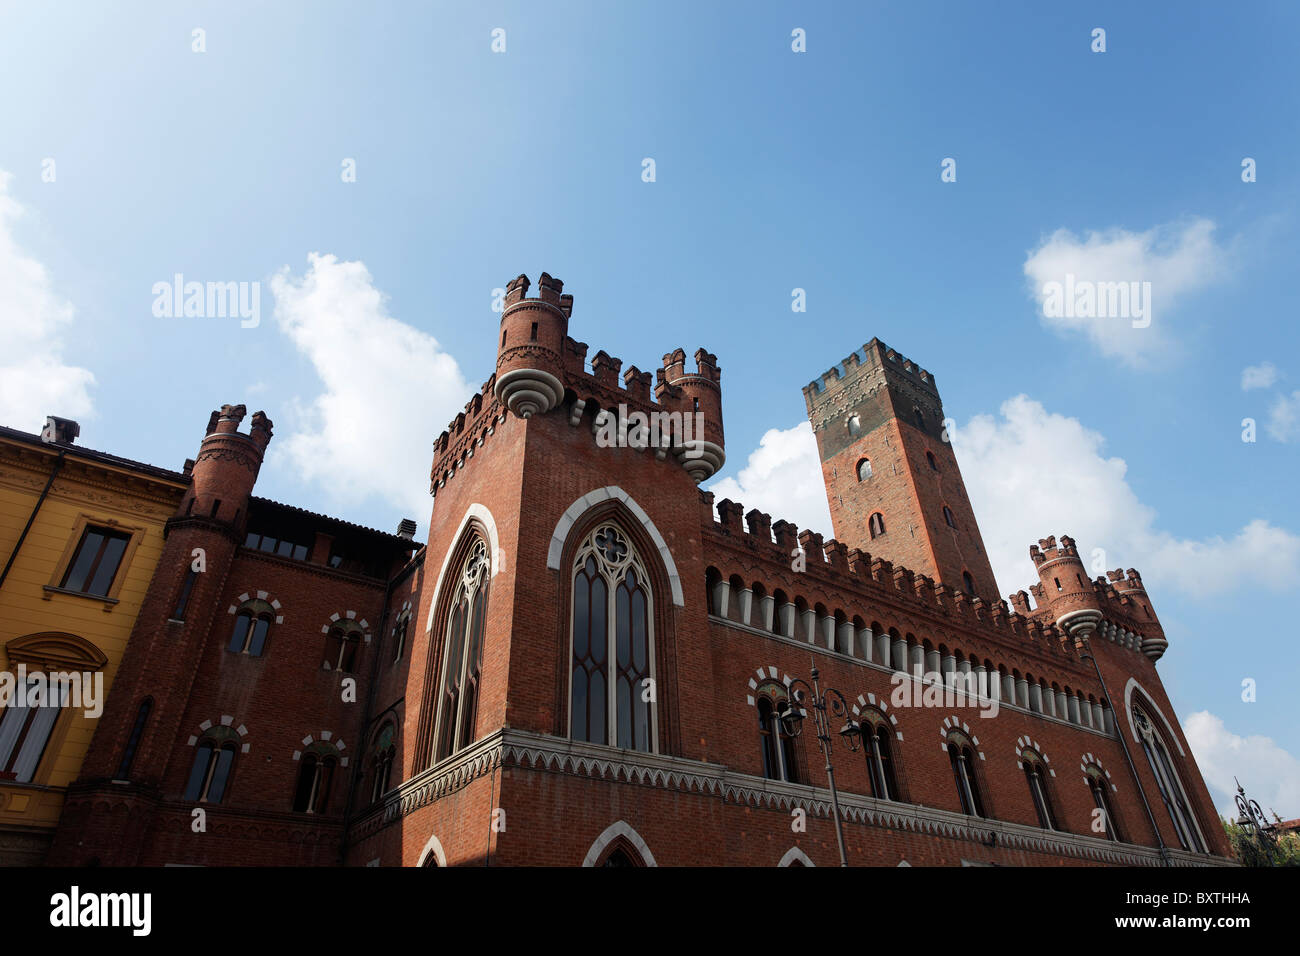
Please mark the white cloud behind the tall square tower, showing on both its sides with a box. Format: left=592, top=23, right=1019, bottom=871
left=710, top=395, right=1300, bottom=598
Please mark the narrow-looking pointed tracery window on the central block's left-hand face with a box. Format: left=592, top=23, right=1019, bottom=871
left=436, top=538, right=491, bottom=760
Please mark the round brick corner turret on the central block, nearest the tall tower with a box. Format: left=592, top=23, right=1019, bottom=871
left=654, top=349, right=727, bottom=483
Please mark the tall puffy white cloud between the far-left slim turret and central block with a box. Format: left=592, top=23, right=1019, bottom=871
left=270, top=252, right=477, bottom=527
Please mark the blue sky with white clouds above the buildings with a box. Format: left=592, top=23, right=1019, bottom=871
left=0, top=0, right=1300, bottom=818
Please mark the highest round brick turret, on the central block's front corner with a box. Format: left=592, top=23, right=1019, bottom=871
left=495, top=272, right=573, bottom=419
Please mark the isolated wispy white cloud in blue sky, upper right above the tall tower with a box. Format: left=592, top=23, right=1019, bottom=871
left=1024, top=219, right=1226, bottom=365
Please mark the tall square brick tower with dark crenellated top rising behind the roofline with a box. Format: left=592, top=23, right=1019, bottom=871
left=803, top=338, right=998, bottom=601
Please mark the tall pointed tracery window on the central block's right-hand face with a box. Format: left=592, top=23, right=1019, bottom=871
left=569, top=524, right=657, bottom=752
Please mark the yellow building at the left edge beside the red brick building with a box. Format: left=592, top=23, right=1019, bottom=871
left=0, top=418, right=190, bottom=865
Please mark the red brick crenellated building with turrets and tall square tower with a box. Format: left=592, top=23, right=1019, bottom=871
left=49, top=273, right=1230, bottom=866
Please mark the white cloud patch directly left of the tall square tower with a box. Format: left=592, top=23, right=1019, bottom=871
left=709, top=421, right=831, bottom=537
